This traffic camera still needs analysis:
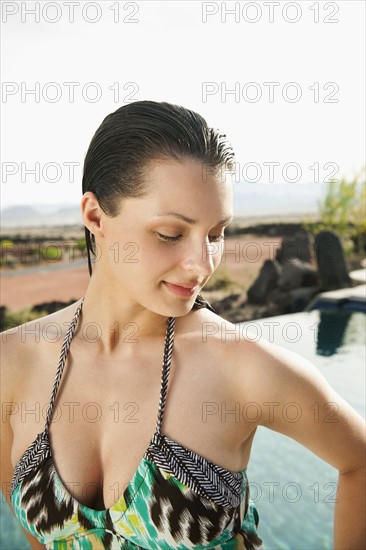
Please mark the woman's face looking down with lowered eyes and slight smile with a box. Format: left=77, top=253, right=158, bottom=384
left=96, top=160, right=232, bottom=317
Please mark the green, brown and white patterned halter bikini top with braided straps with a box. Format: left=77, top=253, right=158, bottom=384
left=11, top=298, right=263, bottom=550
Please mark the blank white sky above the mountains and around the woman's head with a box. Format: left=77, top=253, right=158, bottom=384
left=1, top=0, right=365, bottom=208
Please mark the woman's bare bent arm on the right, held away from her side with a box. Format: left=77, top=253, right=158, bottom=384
left=236, top=340, right=366, bottom=550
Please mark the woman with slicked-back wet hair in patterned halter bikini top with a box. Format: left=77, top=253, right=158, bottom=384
left=1, top=101, right=365, bottom=550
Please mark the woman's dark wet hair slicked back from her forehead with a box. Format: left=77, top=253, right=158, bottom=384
left=82, top=101, right=235, bottom=311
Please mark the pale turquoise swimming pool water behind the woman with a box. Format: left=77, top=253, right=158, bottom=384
left=0, top=310, right=366, bottom=550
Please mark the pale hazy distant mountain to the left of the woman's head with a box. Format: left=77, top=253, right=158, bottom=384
left=0, top=205, right=82, bottom=228
